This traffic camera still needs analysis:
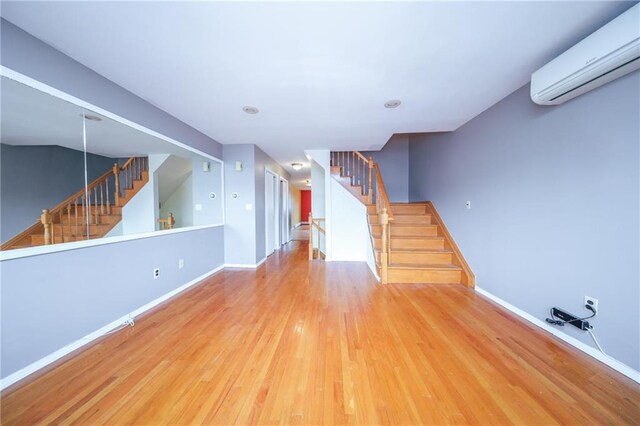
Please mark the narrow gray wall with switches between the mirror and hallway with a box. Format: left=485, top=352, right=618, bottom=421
left=223, top=145, right=256, bottom=265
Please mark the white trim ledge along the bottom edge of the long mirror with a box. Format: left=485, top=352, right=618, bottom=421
left=0, top=223, right=224, bottom=262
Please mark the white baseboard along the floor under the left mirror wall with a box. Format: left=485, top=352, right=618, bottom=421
left=0, top=265, right=225, bottom=390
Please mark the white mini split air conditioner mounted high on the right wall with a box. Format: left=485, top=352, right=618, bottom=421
left=531, top=4, right=640, bottom=105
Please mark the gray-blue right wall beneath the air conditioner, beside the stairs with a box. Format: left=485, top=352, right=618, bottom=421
left=409, top=72, right=640, bottom=370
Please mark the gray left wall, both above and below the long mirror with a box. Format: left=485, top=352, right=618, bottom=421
left=0, top=20, right=224, bottom=377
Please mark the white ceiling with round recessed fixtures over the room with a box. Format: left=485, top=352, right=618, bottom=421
left=2, top=1, right=633, bottom=185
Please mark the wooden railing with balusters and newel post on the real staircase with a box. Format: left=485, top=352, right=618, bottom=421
left=331, top=151, right=393, bottom=284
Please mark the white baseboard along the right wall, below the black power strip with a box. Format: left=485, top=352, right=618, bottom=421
left=476, top=287, right=640, bottom=383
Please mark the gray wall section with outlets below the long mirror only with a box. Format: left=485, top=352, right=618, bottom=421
left=1, top=226, right=224, bottom=377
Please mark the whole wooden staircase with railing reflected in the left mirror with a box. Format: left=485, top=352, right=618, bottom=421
left=0, top=157, right=149, bottom=250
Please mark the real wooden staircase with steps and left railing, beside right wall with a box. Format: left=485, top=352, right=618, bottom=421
left=331, top=151, right=475, bottom=287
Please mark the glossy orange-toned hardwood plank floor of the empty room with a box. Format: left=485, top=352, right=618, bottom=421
left=1, top=242, right=640, bottom=425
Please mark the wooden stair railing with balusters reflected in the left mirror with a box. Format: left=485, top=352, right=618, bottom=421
left=0, top=157, right=149, bottom=250
